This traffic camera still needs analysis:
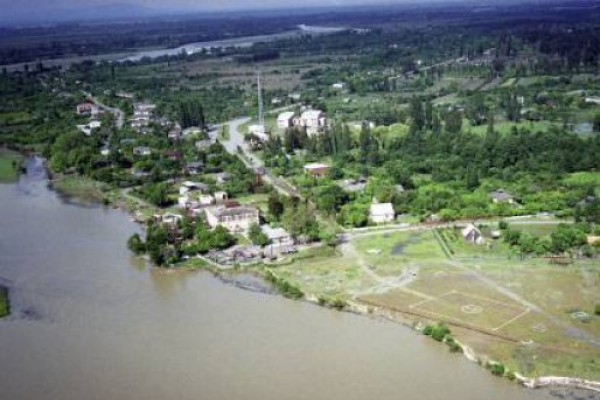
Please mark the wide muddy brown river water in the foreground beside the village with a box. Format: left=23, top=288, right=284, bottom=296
left=0, top=158, right=551, bottom=400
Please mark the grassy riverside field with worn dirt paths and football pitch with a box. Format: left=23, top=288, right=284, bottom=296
left=274, top=224, right=600, bottom=379
